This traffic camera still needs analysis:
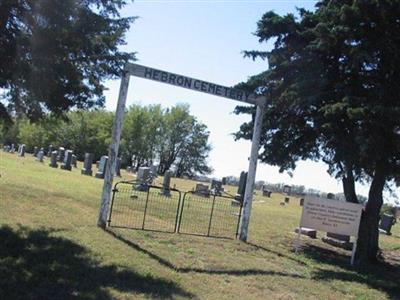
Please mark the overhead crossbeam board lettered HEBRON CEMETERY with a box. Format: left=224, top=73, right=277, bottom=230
left=126, top=63, right=258, bottom=104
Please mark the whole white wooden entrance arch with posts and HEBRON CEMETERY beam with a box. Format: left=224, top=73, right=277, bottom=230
left=97, top=63, right=265, bottom=241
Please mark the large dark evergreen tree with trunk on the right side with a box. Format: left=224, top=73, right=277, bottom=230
left=236, top=0, right=400, bottom=263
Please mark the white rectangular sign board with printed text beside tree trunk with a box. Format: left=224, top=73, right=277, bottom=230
left=300, top=198, right=363, bottom=236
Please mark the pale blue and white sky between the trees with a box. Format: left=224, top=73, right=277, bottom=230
left=105, top=0, right=400, bottom=202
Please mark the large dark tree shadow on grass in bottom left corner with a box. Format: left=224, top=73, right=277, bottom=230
left=0, top=226, right=193, bottom=299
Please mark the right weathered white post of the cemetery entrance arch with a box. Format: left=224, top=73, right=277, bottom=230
left=239, top=99, right=265, bottom=242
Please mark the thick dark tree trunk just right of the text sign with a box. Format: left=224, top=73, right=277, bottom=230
left=355, top=169, right=385, bottom=265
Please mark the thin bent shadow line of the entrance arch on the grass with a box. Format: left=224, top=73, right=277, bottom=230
left=105, top=229, right=304, bottom=278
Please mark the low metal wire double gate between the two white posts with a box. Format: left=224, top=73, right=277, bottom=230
left=108, top=182, right=242, bottom=237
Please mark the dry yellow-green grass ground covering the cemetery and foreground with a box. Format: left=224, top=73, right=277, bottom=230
left=0, top=152, right=400, bottom=299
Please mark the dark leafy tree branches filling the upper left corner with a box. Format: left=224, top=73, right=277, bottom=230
left=0, top=0, right=134, bottom=121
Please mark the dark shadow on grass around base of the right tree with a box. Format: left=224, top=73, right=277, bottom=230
left=303, top=245, right=400, bottom=299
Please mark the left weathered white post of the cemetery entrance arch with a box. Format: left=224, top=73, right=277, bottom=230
left=97, top=68, right=130, bottom=229
